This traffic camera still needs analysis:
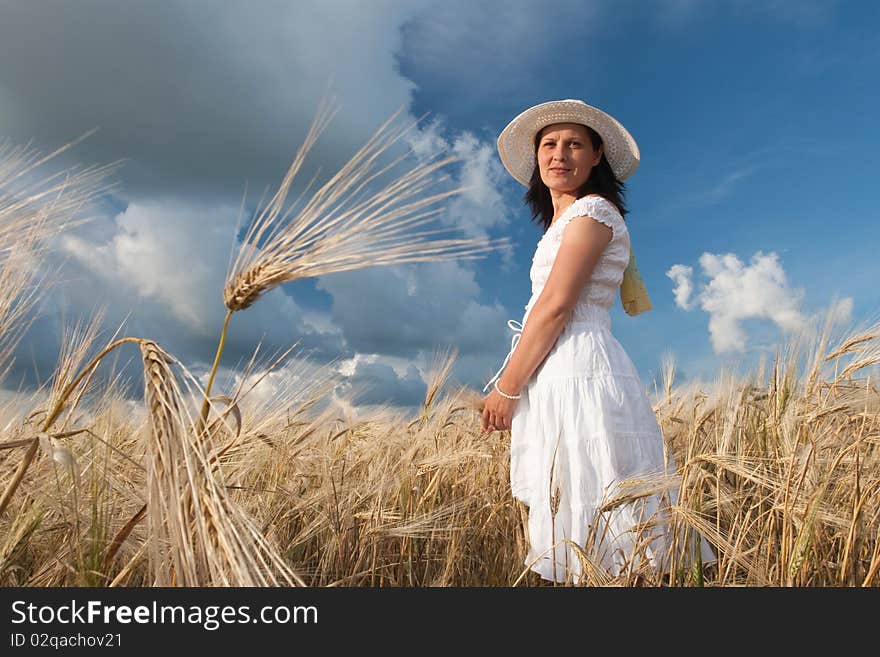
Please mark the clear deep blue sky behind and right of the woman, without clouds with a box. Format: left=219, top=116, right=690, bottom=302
left=402, top=2, right=880, bottom=384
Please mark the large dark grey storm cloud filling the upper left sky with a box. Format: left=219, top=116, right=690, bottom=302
left=0, top=0, right=424, bottom=198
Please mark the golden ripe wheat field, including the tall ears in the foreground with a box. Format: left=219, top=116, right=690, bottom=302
left=0, top=120, right=880, bottom=587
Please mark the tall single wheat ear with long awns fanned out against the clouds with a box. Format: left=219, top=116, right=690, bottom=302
left=199, top=102, right=510, bottom=422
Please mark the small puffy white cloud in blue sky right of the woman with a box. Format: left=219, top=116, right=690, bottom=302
left=666, top=251, right=805, bottom=354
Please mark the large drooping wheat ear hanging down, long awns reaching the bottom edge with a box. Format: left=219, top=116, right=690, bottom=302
left=140, top=340, right=304, bottom=586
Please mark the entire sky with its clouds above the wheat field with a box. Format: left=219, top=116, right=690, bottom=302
left=0, top=0, right=880, bottom=405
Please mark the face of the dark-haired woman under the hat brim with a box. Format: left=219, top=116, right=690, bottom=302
left=537, top=123, right=602, bottom=194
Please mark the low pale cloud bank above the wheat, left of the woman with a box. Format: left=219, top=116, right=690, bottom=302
left=15, top=164, right=506, bottom=404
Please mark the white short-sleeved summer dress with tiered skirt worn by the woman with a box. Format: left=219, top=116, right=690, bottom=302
left=487, top=195, right=716, bottom=582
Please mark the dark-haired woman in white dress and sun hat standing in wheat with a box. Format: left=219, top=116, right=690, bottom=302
left=482, top=100, right=715, bottom=582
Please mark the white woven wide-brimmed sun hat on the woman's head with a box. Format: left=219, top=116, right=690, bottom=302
left=498, top=99, right=639, bottom=187
